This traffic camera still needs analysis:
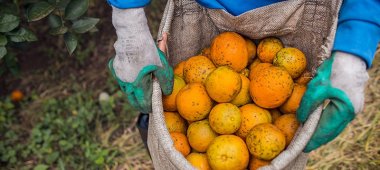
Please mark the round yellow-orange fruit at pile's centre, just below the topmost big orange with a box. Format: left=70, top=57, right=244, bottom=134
left=205, top=66, right=242, bottom=103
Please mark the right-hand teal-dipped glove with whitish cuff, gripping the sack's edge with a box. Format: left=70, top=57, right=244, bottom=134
left=297, top=52, right=368, bottom=152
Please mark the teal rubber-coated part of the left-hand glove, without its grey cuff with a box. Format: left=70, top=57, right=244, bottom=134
left=108, top=48, right=174, bottom=113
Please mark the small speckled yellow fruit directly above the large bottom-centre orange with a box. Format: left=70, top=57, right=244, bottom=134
left=209, top=103, right=241, bottom=135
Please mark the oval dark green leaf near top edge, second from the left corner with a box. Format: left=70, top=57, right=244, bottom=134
left=27, top=1, right=55, bottom=22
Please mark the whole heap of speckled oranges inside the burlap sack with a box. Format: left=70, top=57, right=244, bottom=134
left=163, top=32, right=311, bottom=170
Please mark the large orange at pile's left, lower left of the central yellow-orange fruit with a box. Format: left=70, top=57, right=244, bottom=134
left=176, top=83, right=213, bottom=121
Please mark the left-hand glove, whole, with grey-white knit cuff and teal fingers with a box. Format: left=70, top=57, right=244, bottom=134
left=109, top=7, right=174, bottom=113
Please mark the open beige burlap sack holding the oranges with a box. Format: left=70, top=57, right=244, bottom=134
left=148, top=0, right=342, bottom=170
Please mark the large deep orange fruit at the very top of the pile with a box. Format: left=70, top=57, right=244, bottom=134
left=210, top=32, right=248, bottom=72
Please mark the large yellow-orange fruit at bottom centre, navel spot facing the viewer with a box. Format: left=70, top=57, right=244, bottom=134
left=206, top=135, right=249, bottom=170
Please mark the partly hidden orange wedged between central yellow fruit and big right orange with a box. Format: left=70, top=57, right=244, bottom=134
left=231, top=74, right=252, bottom=106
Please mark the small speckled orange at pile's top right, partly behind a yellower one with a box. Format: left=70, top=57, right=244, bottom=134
left=257, top=38, right=284, bottom=63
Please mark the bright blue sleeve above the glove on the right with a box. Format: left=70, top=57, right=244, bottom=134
left=333, top=0, right=380, bottom=68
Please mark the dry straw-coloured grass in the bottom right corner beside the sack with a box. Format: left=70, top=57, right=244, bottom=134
left=307, top=52, right=380, bottom=170
